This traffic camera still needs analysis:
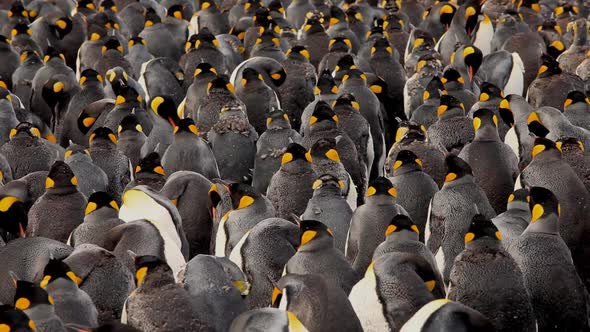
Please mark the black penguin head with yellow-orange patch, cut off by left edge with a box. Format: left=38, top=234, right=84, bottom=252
left=0, top=195, right=28, bottom=242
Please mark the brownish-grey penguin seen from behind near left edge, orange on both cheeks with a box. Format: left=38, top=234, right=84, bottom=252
left=27, top=161, right=87, bottom=243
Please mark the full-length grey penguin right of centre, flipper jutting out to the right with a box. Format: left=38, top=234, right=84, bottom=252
left=425, top=154, right=496, bottom=285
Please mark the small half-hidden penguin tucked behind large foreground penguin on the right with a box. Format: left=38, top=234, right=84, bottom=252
left=492, top=189, right=531, bottom=252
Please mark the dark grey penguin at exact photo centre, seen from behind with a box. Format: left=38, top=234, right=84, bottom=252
left=266, top=143, right=316, bottom=219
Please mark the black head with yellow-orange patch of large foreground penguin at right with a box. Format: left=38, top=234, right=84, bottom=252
left=529, top=187, right=561, bottom=228
